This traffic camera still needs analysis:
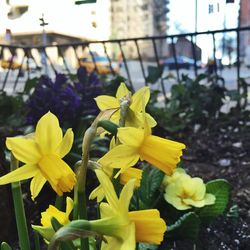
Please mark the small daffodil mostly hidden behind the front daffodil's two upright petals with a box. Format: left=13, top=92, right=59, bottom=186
left=89, top=167, right=142, bottom=202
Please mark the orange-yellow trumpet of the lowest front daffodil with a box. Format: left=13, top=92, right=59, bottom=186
left=129, top=209, right=167, bottom=244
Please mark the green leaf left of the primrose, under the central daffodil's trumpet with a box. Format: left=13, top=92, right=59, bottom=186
left=138, top=166, right=164, bottom=209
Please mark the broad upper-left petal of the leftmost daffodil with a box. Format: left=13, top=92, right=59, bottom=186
left=6, top=137, right=41, bottom=164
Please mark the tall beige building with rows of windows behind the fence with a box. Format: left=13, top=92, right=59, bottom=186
left=111, top=0, right=168, bottom=59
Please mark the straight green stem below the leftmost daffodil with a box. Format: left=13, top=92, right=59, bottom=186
left=10, top=154, right=30, bottom=250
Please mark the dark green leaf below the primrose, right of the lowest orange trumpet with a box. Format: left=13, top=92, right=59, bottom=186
left=166, top=212, right=200, bottom=241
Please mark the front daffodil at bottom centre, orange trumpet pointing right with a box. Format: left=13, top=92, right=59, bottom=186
left=90, top=170, right=166, bottom=250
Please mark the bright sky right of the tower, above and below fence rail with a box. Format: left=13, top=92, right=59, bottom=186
left=168, top=0, right=240, bottom=63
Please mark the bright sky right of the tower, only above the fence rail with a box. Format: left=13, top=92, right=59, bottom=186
left=169, top=0, right=240, bottom=34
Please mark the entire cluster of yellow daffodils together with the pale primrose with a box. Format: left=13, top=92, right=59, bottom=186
left=0, top=82, right=223, bottom=250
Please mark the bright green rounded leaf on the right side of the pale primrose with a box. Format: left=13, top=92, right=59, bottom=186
left=198, top=179, right=230, bottom=223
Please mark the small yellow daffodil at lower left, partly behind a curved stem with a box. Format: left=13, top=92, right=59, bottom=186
left=32, top=197, right=74, bottom=241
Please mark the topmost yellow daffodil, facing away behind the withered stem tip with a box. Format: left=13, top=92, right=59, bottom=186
left=95, top=83, right=156, bottom=127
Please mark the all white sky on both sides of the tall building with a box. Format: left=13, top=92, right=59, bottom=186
left=0, top=0, right=240, bottom=61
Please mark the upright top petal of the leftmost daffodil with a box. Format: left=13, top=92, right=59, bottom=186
left=35, top=112, right=62, bottom=154
